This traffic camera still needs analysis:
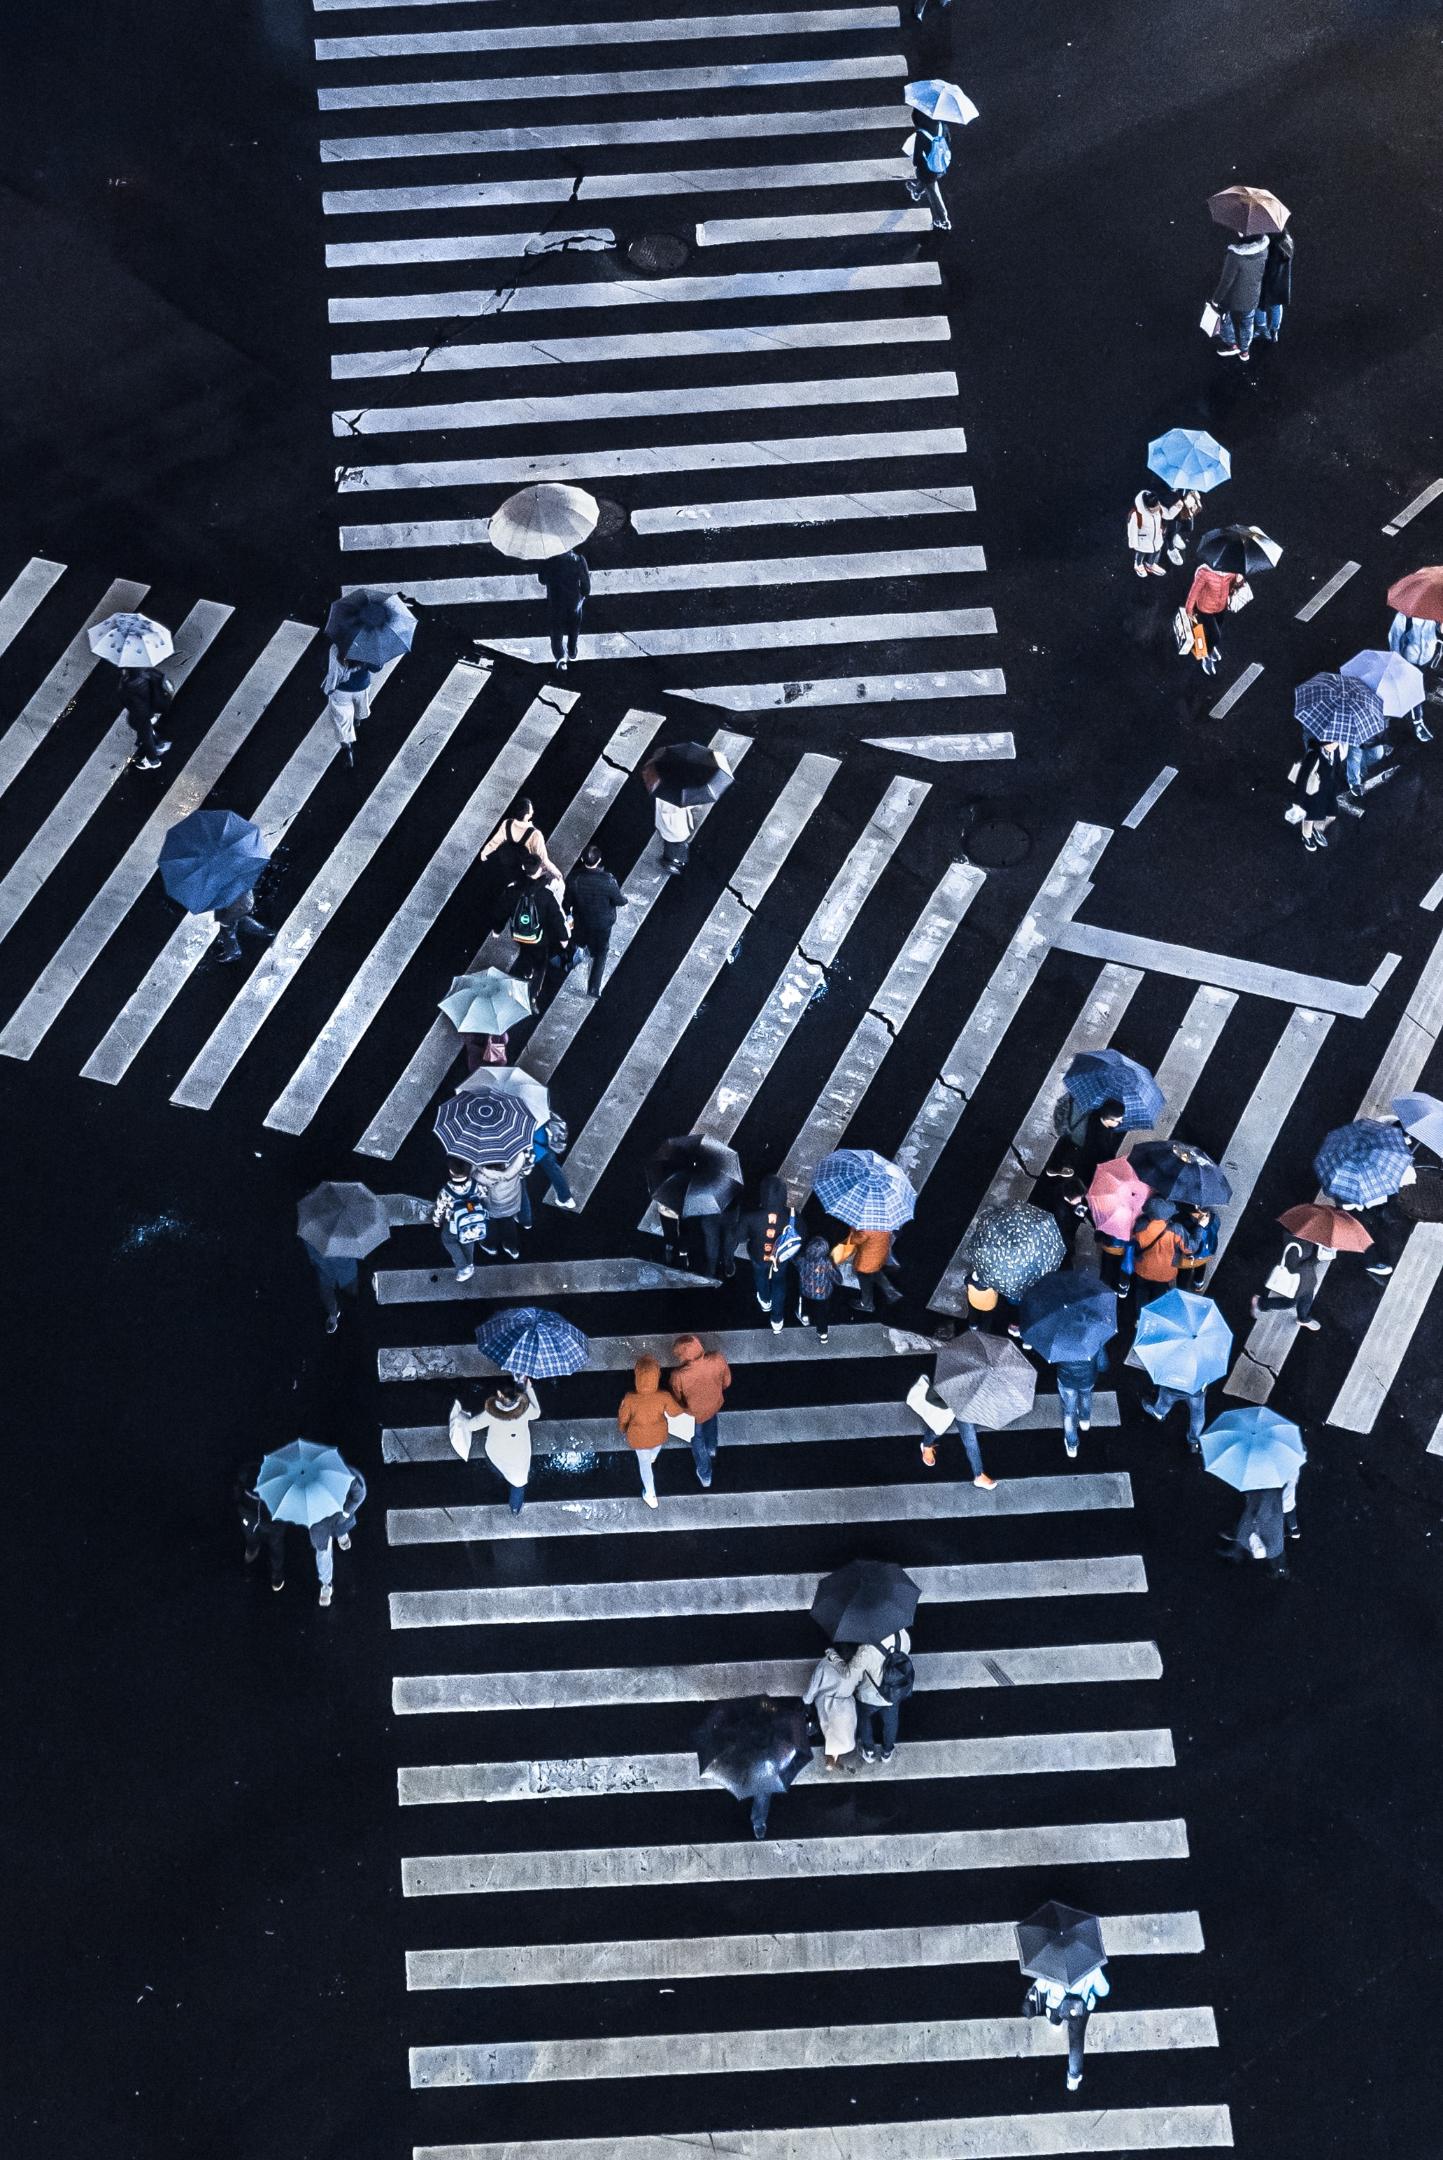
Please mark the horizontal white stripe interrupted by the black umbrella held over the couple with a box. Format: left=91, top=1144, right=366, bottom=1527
left=389, top=1563, right=1147, bottom=1629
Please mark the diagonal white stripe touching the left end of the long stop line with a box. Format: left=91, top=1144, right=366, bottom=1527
left=896, top=825, right=1112, bottom=1190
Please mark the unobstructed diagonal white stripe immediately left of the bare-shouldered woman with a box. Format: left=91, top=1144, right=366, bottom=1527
left=264, top=687, right=570, bottom=1132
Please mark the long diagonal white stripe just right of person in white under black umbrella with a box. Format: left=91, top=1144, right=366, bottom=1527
left=540, top=752, right=840, bottom=1207
